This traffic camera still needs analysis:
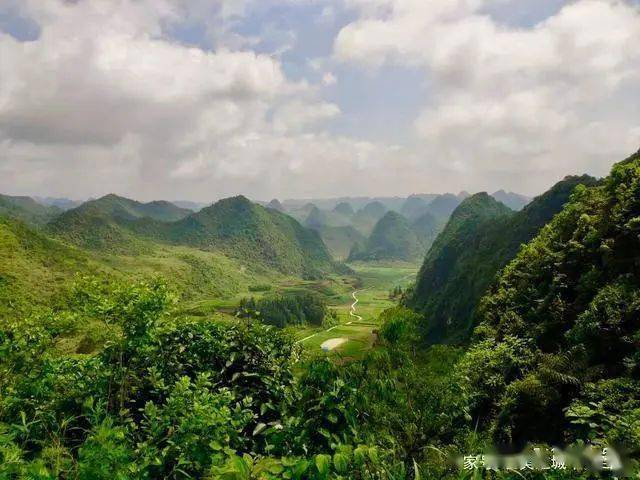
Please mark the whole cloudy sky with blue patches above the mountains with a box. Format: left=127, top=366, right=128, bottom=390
left=0, top=0, right=640, bottom=202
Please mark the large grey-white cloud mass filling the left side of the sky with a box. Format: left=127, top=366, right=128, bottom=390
left=0, top=0, right=384, bottom=200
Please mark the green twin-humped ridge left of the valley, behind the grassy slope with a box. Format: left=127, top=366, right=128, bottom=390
left=48, top=196, right=332, bottom=276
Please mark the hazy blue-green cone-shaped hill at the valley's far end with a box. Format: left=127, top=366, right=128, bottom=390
left=349, top=212, right=424, bottom=261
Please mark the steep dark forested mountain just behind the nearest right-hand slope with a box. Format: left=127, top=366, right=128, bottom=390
left=408, top=176, right=595, bottom=342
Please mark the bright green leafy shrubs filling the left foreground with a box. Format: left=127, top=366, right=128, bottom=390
left=0, top=281, right=407, bottom=479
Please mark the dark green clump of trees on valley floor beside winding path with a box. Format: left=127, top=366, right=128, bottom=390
left=236, top=293, right=330, bottom=328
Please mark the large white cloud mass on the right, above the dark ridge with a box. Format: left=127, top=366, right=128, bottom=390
left=334, top=0, right=640, bottom=191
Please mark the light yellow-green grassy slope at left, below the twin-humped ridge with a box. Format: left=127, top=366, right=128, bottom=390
left=0, top=218, right=283, bottom=320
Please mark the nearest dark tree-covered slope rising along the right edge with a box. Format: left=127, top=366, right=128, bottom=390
left=467, top=150, right=640, bottom=449
